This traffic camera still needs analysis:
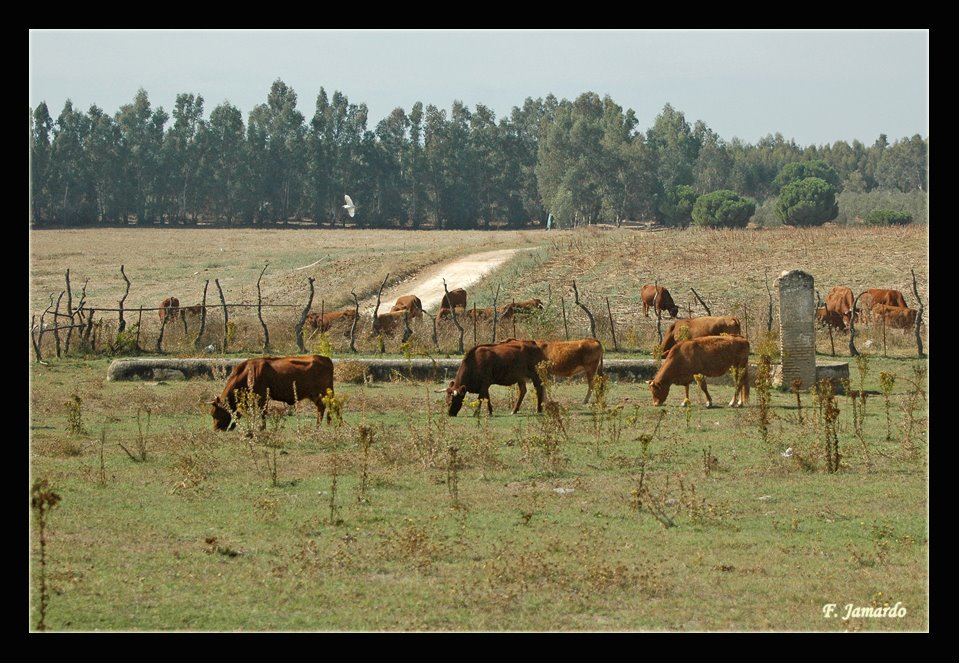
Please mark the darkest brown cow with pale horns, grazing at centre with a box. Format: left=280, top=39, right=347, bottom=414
left=446, top=340, right=546, bottom=417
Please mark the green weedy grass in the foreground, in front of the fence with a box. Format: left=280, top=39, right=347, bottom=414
left=30, top=357, right=928, bottom=631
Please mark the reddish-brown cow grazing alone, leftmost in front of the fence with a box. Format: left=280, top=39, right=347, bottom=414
left=210, top=355, right=333, bottom=430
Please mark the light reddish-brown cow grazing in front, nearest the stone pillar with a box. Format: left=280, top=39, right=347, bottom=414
left=647, top=336, right=749, bottom=407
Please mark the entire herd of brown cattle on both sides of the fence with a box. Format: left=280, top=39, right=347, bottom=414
left=152, top=285, right=917, bottom=430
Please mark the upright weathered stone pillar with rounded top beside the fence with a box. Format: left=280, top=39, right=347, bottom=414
left=777, top=270, right=816, bottom=389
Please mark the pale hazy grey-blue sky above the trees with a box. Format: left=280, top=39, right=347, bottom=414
left=29, top=30, right=929, bottom=145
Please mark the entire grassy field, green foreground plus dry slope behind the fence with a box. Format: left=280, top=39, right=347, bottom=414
left=29, top=228, right=929, bottom=631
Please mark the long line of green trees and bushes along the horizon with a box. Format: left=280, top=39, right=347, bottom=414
left=30, top=79, right=929, bottom=228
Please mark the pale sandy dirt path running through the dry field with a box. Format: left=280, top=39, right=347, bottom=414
left=360, top=249, right=530, bottom=313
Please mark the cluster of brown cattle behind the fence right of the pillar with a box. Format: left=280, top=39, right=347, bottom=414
left=816, top=285, right=919, bottom=333
